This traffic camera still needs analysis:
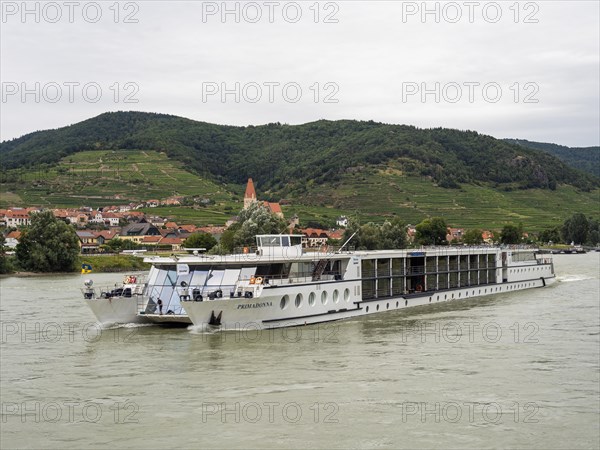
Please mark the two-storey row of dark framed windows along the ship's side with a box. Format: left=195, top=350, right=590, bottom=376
left=361, top=254, right=497, bottom=300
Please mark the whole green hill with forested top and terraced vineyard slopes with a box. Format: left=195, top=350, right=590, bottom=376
left=0, top=112, right=600, bottom=228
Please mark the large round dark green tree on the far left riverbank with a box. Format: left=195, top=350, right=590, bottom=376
left=16, top=211, right=79, bottom=272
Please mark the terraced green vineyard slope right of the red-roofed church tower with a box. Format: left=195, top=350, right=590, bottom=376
left=296, top=170, right=600, bottom=231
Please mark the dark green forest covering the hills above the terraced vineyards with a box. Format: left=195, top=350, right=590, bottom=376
left=0, top=112, right=600, bottom=197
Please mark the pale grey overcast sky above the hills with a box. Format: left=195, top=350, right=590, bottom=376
left=0, top=1, right=600, bottom=146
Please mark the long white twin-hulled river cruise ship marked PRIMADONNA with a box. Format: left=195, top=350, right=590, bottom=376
left=84, top=235, right=555, bottom=330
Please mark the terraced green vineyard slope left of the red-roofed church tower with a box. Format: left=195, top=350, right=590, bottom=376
left=0, top=150, right=240, bottom=208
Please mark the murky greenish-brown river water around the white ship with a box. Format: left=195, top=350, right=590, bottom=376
left=0, top=253, right=600, bottom=449
